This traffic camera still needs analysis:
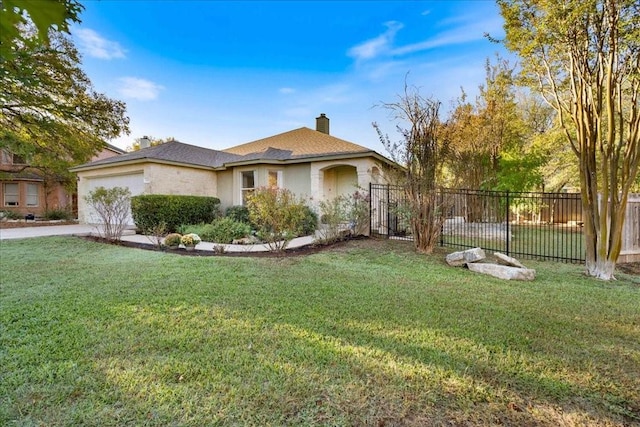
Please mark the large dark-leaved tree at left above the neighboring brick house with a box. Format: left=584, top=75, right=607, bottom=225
left=0, top=1, right=129, bottom=189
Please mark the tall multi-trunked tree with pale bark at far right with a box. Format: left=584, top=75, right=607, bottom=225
left=498, top=0, right=640, bottom=280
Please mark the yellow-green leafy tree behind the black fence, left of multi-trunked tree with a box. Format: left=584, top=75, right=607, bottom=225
left=443, top=57, right=543, bottom=191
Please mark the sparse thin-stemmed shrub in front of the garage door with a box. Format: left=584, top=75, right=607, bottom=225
left=84, top=187, right=131, bottom=240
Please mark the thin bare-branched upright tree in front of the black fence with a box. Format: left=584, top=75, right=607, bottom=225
left=373, top=84, right=448, bottom=254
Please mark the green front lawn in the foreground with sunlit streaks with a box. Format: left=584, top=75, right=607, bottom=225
left=0, top=238, right=640, bottom=426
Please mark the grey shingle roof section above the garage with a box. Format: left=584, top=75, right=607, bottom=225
left=73, top=141, right=242, bottom=169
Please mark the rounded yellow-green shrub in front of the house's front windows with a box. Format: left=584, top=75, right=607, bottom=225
left=247, top=187, right=307, bottom=251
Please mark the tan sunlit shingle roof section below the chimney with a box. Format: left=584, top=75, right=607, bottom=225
left=224, top=127, right=371, bottom=160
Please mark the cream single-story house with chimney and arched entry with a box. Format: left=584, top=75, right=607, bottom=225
left=71, top=114, right=394, bottom=227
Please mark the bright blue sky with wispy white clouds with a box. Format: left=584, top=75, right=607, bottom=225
left=72, top=0, right=507, bottom=154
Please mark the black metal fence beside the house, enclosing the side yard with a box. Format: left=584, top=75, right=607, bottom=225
left=369, top=184, right=585, bottom=263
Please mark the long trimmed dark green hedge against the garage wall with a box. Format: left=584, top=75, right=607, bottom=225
left=131, top=194, right=220, bottom=233
